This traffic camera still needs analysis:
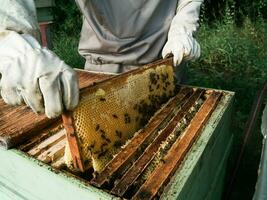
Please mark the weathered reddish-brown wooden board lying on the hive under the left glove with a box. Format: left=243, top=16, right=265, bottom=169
left=0, top=70, right=111, bottom=149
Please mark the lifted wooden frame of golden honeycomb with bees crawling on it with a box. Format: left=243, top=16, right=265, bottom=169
left=63, top=58, right=175, bottom=172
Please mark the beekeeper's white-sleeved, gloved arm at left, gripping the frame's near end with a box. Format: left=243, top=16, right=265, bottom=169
left=0, top=0, right=79, bottom=118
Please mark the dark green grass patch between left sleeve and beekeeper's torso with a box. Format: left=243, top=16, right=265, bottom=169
left=53, top=0, right=85, bottom=68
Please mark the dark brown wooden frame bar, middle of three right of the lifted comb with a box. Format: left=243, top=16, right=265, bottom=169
left=111, top=90, right=204, bottom=196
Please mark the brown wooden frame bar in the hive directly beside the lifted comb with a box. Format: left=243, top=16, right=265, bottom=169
left=91, top=88, right=193, bottom=187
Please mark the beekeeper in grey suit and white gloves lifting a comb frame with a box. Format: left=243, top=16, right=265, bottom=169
left=0, top=0, right=203, bottom=118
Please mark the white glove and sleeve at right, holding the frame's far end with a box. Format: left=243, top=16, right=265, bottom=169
left=162, top=0, right=203, bottom=66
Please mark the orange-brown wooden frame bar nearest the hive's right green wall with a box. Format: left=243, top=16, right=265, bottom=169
left=133, top=92, right=221, bottom=200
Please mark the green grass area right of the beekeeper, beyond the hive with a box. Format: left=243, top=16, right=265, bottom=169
left=192, top=17, right=267, bottom=139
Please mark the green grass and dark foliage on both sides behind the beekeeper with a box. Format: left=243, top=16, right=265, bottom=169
left=53, top=0, right=267, bottom=199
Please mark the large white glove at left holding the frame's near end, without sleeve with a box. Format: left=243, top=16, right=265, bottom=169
left=0, top=30, right=79, bottom=118
